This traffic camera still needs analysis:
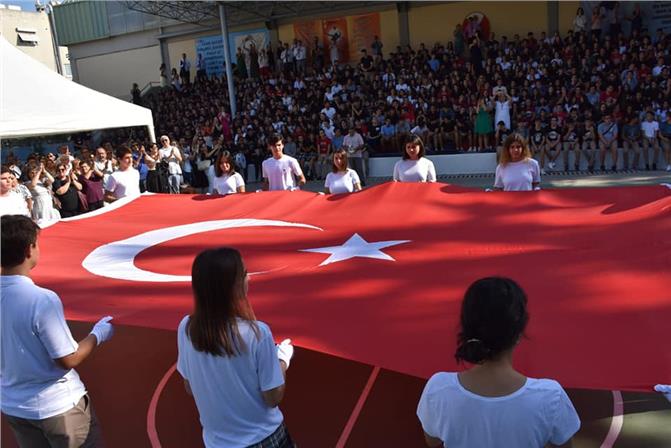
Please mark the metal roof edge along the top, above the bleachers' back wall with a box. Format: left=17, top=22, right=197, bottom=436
left=122, top=0, right=394, bottom=27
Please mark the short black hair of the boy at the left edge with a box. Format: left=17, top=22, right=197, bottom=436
left=0, top=215, right=40, bottom=268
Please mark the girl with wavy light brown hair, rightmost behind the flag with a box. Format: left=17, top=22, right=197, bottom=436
left=494, top=134, right=541, bottom=191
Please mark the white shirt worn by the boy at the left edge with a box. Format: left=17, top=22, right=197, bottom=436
left=0, top=275, right=86, bottom=420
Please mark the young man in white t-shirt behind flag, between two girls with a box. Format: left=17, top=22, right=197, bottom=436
left=261, top=134, right=305, bottom=191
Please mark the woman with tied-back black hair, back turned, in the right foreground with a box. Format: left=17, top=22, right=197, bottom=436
left=417, top=277, right=580, bottom=448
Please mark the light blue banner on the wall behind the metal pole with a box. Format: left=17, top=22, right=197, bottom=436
left=192, top=28, right=270, bottom=77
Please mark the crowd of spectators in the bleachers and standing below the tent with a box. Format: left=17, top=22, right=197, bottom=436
left=5, top=10, right=671, bottom=217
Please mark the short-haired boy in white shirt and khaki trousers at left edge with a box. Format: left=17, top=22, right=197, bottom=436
left=0, top=216, right=114, bottom=447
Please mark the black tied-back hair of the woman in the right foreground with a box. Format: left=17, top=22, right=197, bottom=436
left=454, top=277, right=529, bottom=364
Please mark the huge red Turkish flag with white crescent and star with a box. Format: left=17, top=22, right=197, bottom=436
left=34, top=183, right=671, bottom=390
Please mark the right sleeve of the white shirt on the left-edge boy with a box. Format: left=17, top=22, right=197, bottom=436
left=34, top=293, right=79, bottom=359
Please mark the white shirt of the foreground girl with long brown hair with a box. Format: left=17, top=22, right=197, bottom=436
left=177, top=316, right=284, bottom=448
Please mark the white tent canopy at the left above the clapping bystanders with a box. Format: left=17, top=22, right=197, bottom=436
left=0, top=36, right=154, bottom=141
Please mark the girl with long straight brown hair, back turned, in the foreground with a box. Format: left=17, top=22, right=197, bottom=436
left=177, top=247, right=294, bottom=448
